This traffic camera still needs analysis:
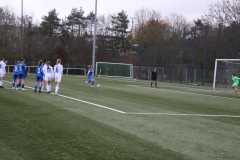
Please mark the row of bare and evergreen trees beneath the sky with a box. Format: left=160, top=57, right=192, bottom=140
left=0, top=0, right=240, bottom=67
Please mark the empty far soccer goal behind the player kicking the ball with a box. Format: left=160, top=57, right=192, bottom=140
left=95, top=62, right=133, bottom=78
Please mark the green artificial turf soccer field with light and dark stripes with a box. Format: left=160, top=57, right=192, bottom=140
left=0, top=74, right=240, bottom=160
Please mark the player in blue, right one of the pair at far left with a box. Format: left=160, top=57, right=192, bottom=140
left=16, top=58, right=27, bottom=90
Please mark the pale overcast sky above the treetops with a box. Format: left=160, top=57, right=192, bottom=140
left=0, top=0, right=218, bottom=22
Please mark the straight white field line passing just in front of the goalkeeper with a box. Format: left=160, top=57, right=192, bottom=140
left=128, top=85, right=240, bottom=101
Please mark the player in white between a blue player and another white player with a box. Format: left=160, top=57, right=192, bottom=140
left=43, top=61, right=53, bottom=93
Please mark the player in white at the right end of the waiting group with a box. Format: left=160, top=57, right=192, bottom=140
left=53, top=59, right=63, bottom=95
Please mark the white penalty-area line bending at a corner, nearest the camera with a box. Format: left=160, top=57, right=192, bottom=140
left=4, top=81, right=240, bottom=118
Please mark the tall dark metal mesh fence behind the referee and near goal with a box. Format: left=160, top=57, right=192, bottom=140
left=134, top=22, right=240, bottom=85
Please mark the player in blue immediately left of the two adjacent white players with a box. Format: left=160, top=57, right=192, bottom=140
left=34, top=60, right=43, bottom=93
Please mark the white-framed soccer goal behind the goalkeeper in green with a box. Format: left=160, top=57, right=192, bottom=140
left=213, top=59, right=240, bottom=91
